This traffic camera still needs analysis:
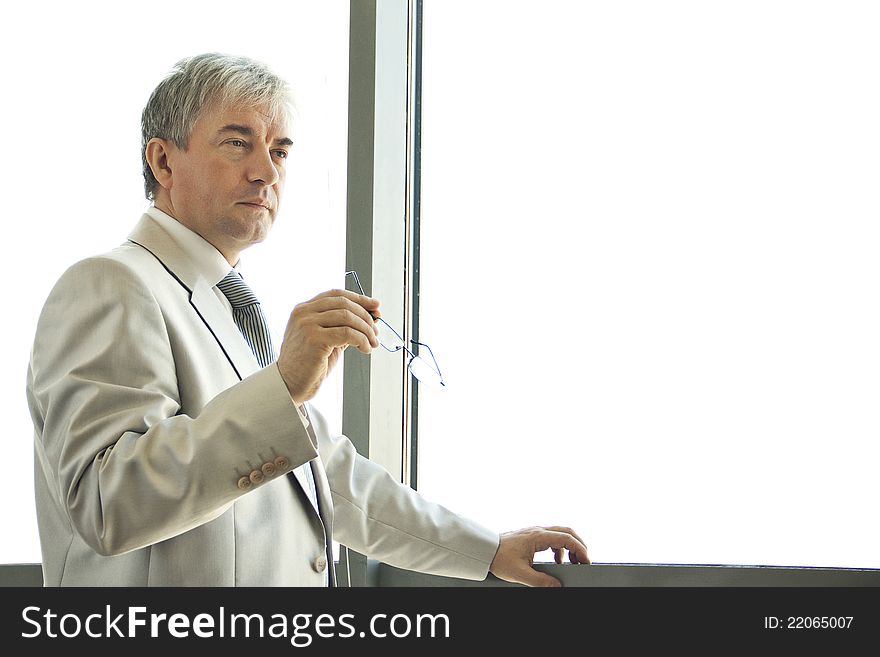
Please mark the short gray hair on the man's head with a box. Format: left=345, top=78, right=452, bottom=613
left=141, top=53, right=293, bottom=201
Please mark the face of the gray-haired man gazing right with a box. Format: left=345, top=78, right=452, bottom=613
left=162, top=102, right=292, bottom=264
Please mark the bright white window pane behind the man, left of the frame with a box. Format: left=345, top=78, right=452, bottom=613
left=0, top=0, right=349, bottom=562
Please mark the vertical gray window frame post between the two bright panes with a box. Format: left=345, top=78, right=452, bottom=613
left=339, top=0, right=421, bottom=586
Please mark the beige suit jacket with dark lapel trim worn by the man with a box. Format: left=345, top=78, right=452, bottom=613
left=27, top=215, right=499, bottom=586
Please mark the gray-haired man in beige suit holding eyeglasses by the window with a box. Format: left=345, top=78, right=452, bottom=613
left=27, top=54, right=589, bottom=586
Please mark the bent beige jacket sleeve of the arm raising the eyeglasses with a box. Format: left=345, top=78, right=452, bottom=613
left=28, top=258, right=317, bottom=555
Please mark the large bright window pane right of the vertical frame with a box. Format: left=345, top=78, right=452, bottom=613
left=418, top=0, right=880, bottom=567
